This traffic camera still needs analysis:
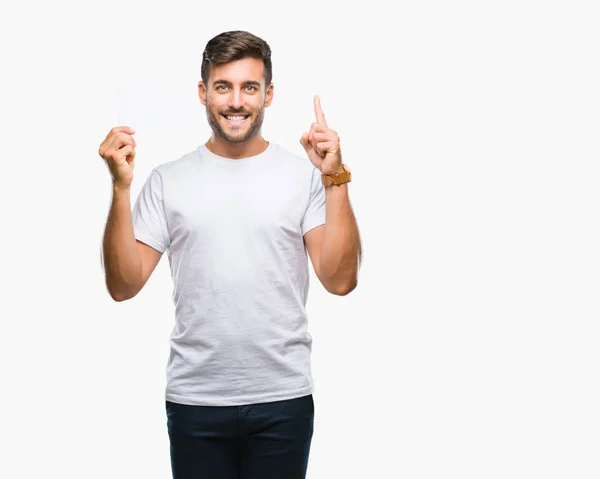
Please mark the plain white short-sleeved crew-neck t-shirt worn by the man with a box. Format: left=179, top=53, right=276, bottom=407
left=132, top=142, right=325, bottom=406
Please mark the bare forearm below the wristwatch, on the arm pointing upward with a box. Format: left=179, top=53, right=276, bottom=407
left=319, top=183, right=361, bottom=294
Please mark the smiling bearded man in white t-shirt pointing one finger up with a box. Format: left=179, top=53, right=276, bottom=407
left=99, top=31, right=361, bottom=479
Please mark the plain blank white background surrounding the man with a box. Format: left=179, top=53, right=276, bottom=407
left=0, top=0, right=600, bottom=479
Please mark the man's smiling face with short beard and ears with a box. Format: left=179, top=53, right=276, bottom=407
left=198, top=58, right=273, bottom=143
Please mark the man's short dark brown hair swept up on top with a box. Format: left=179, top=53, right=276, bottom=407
left=201, top=30, right=273, bottom=88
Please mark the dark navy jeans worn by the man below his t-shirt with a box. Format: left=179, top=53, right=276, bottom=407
left=166, top=395, right=314, bottom=479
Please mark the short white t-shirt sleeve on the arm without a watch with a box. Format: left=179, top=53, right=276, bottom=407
left=131, top=169, right=169, bottom=253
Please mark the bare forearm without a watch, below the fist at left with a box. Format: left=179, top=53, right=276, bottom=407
left=102, top=187, right=142, bottom=301
